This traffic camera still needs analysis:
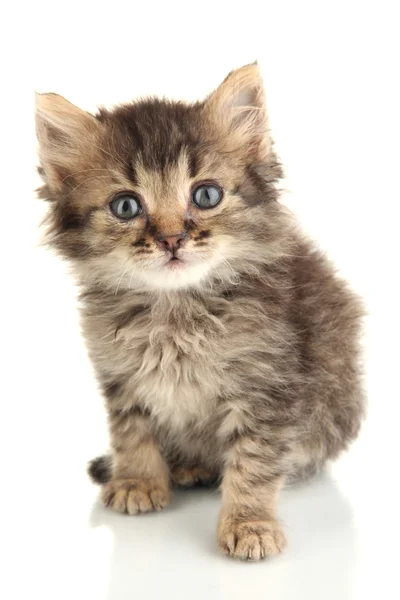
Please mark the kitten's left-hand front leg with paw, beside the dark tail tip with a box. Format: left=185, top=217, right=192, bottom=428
left=102, top=400, right=171, bottom=515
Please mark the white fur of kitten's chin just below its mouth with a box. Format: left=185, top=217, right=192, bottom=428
left=139, top=261, right=212, bottom=291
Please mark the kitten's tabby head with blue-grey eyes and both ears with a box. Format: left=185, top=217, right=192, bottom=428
left=37, top=64, right=281, bottom=290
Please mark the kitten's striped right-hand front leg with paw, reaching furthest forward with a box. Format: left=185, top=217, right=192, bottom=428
left=218, top=437, right=286, bottom=560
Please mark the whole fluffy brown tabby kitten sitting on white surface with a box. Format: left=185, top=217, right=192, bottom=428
left=37, top=64, right=364, bottom=560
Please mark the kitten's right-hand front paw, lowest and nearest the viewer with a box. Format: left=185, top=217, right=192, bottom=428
left=218, top=517, right=286, bottom=560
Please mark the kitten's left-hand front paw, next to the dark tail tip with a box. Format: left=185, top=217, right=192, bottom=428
left=101, top=479, right=171, bottom=515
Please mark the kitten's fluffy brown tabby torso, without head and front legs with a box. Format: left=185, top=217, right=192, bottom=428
left=83, top=241, right=362, bottom=477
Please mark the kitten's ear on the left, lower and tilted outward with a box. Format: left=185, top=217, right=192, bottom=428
left=36, top=94, right=100, bottom=191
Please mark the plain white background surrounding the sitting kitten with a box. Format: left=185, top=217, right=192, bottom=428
left=0, top=0, right=400, bottom=600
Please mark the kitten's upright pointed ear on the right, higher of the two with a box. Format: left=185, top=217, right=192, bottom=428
left=205, top=63, right=271, bottom=156
